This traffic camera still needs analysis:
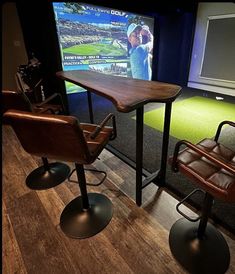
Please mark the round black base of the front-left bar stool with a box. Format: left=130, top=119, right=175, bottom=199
left=60, top=193, right=113, bottom=239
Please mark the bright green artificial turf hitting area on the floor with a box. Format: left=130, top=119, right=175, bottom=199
left=141, top=96, right=235, bottom=143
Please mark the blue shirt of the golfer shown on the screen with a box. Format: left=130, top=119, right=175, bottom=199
left=130, top=45, right=152, bottom=80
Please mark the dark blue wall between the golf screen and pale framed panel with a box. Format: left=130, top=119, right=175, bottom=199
left=153, top=11, right=196, bottom=86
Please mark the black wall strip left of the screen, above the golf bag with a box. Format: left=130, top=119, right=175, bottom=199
left=16, top=1, right=68, bottom=112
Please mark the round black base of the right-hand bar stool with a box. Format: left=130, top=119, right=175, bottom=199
left=169, top=218, right=230, bottom=274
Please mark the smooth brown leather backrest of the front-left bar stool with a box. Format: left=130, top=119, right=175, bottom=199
left=4, top=110, right=91, bottom=164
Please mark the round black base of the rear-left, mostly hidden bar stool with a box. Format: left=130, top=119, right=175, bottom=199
left=26, top=162, right=70, bottom=190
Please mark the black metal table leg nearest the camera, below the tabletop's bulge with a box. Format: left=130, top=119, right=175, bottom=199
left=136, top=106, right=144, bottom=206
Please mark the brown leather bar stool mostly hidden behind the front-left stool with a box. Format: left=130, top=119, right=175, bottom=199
left=2, top=90, right=70, bottom=190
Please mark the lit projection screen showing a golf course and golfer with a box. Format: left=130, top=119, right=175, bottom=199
left=53, top=2, right=154, bottom=94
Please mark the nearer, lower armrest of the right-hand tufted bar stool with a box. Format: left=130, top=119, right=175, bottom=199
left=172, top=140, right=235, bottom=174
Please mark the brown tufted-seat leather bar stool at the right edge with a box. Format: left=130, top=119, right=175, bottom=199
left=169, top=121, right=235, bottom=274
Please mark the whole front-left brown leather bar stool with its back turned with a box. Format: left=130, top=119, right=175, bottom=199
left=4, top=110, right=116, bottom=238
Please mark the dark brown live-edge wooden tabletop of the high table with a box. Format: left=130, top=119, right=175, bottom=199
left=56, top=70, right=181, bottom=112
